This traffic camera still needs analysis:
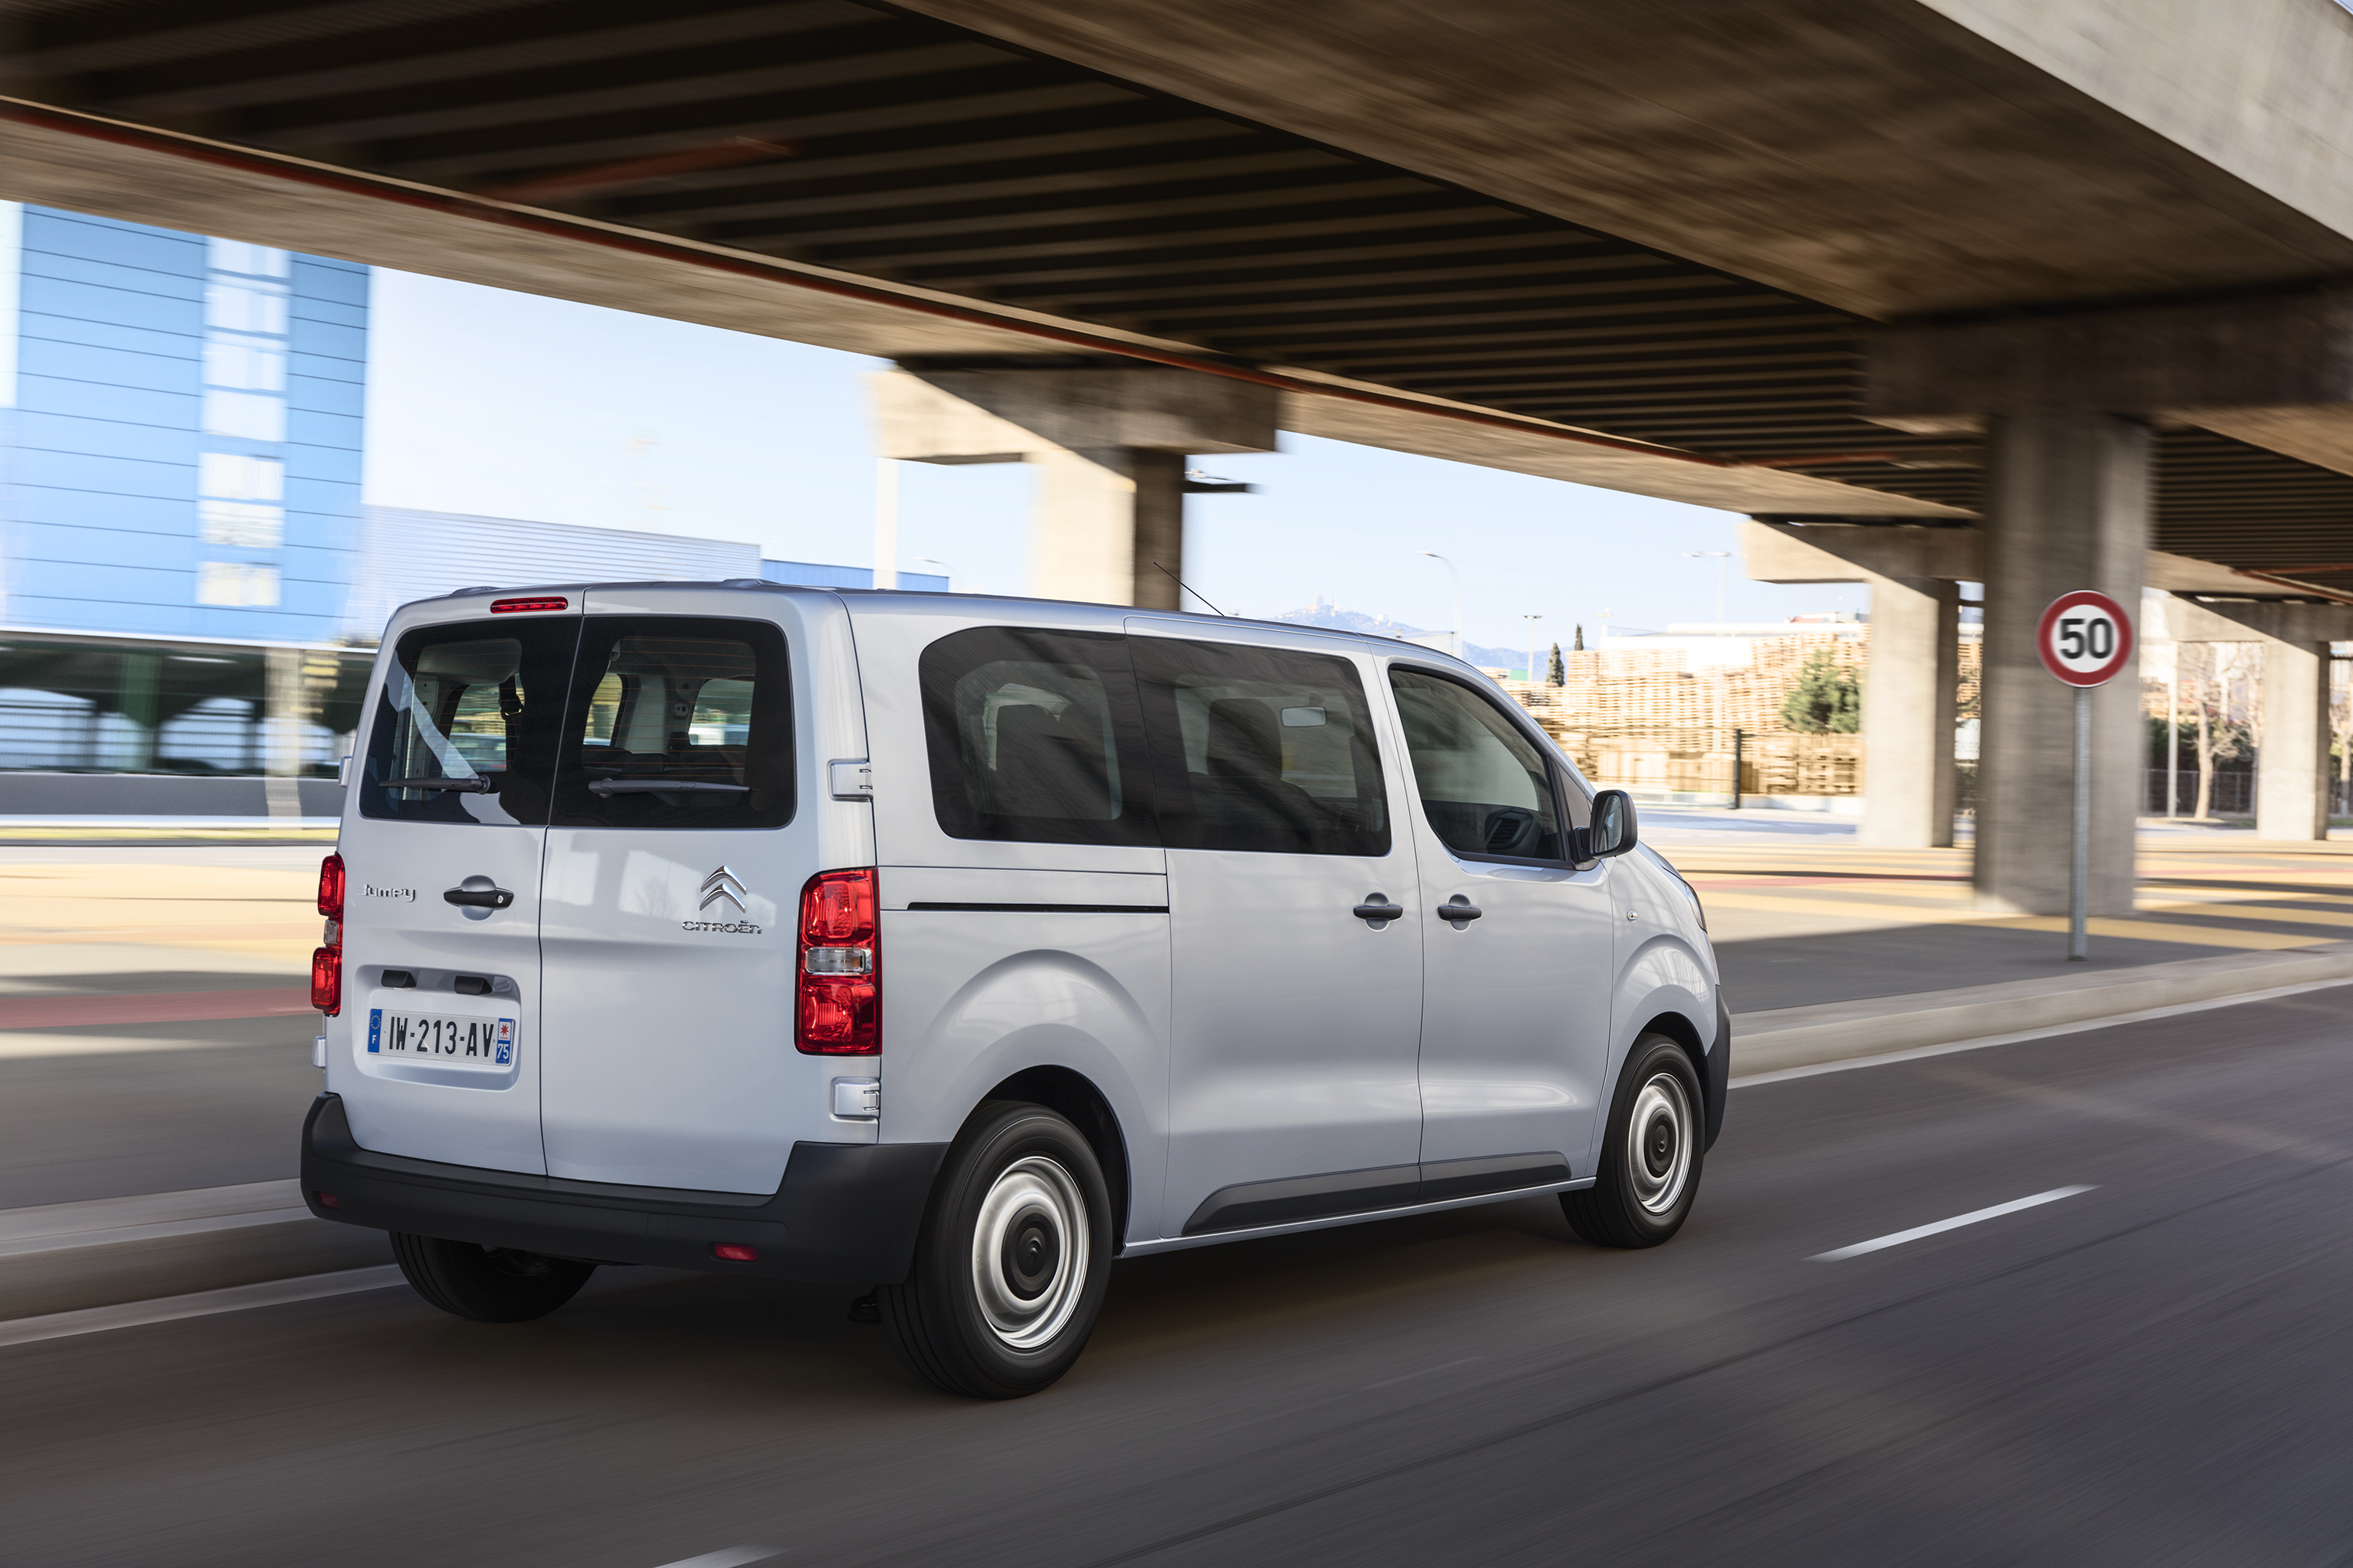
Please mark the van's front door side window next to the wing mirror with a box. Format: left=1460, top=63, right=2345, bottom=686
left=1388, top=668, right=1565, bottom=860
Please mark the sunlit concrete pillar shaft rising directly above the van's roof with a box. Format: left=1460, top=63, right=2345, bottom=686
left=1028, top=447, right=1184, bottom=609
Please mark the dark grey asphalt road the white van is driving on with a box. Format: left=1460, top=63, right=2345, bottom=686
left=0, top=987, right=2353, bottom=1568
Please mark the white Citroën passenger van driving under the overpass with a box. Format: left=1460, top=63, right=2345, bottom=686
left=301, top=581, right=1729, bottom=1399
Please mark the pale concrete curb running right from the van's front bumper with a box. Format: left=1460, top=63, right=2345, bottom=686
left=1732, top=943, right=2353, bottom=1079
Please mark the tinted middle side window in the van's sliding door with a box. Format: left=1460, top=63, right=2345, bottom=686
left=1127, top=637, right=1388, bottom=856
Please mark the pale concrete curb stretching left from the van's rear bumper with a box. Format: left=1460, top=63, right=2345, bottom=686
left=0, top=1183, right=393, bottom=1321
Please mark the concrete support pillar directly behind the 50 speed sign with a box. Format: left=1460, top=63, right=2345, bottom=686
left=1977, top=409, right=2151, bottom=915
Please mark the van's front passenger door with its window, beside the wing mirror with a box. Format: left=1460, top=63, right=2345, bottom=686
left=1391, top=666, right=1617, bottom=1201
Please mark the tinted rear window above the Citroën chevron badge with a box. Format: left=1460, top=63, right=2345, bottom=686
left=553, top=616, right=793, bottom=827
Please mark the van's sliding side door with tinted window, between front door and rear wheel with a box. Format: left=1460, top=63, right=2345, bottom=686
left=1129, top=618, right=1421, bottom=1236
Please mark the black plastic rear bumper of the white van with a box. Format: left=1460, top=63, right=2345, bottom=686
left=301, top=1093, right=949, bottom=1286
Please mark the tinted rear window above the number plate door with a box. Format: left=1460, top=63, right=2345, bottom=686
left=360, top=616, right=578, bottom=825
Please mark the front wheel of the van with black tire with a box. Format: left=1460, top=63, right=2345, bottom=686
left=1560, top=1034, right=1709, bottom=1246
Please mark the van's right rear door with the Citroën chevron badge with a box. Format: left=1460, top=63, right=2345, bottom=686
left=541, top=588, right=811, bottom=1192
